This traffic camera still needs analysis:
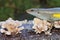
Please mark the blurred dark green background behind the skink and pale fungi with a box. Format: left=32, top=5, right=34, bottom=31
left=0, top=0, right=60, bottom=21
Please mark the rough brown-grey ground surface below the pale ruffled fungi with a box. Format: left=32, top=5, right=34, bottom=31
left=0, top=29, right=60, bottom=40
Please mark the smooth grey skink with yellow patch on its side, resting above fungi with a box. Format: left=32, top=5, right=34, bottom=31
left=26, top=8, right=60, bottom=21
